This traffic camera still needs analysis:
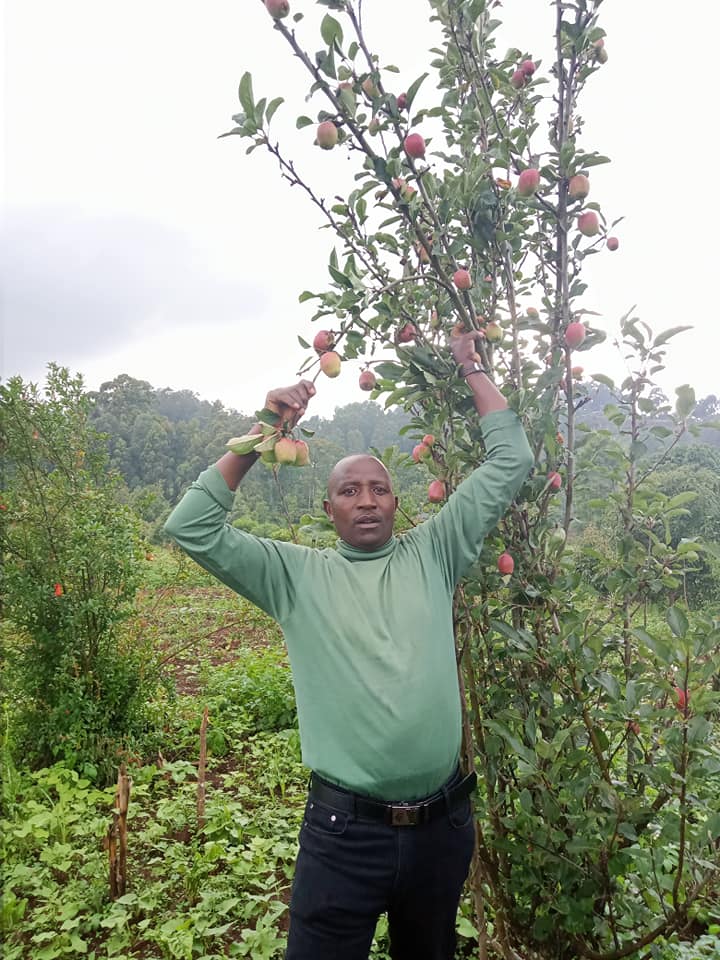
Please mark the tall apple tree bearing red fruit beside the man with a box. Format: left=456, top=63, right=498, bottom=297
left=224, top=0, right=720, bottom=960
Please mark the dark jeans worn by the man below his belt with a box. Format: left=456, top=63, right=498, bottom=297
left=286, top=772, right=475, bottom=960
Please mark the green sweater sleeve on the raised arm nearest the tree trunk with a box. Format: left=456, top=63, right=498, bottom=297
left=420, top=410, right=533, bottom=589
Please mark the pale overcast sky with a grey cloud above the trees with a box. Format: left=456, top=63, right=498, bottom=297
left=2, top=0, right=720, bottom=415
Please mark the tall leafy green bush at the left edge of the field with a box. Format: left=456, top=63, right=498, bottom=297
left=0, top=365, right=153, bottom=776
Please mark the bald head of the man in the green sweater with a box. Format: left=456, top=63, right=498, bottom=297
left=323, top=454, right=397, bottom=550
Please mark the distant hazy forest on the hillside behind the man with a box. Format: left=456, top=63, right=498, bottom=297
left=91, top=374, right=720, bottom=568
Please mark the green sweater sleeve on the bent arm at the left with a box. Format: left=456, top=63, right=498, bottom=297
left=164, top=466, right=307, bottom=623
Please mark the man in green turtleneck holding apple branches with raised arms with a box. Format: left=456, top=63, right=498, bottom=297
left=166, top=332, right=532, bottom=960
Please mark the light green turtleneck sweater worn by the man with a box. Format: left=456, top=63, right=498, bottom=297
left=165, top=410, right=532, bottom=801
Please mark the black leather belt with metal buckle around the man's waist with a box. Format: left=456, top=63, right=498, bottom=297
left=309, top=773, right=477, bottom=827
